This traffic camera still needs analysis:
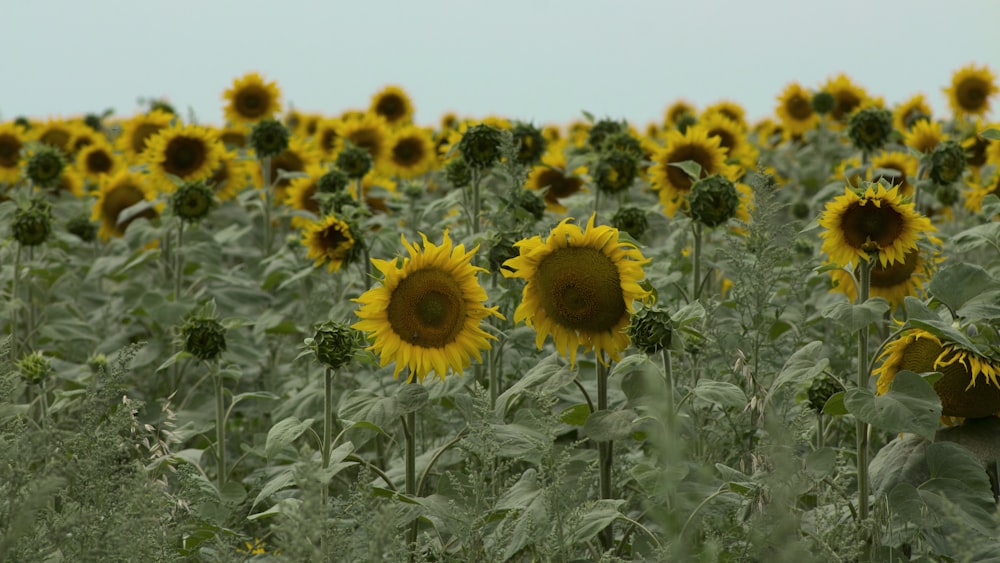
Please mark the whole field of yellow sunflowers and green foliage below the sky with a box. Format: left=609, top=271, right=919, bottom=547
left=0, top=64, right=1000, bottom=563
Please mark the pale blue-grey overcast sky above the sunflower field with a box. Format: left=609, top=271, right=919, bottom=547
left=0, top=0, right=1000, bottom=125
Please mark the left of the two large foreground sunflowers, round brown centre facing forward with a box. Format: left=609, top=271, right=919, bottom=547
left=352, top=231, right=503, bottom=383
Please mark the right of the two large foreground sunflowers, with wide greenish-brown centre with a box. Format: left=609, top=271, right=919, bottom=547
left=500, top=215, right=649, bottom=365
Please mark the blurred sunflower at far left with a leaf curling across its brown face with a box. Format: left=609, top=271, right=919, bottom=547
left=90, top=170, right=163, bottom=240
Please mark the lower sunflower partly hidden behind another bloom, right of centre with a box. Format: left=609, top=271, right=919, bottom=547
left=830, top=243, right=935, bottom=307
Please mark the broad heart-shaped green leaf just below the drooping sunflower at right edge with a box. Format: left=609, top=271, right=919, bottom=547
left=844, top=370, right=941, bottom=440
